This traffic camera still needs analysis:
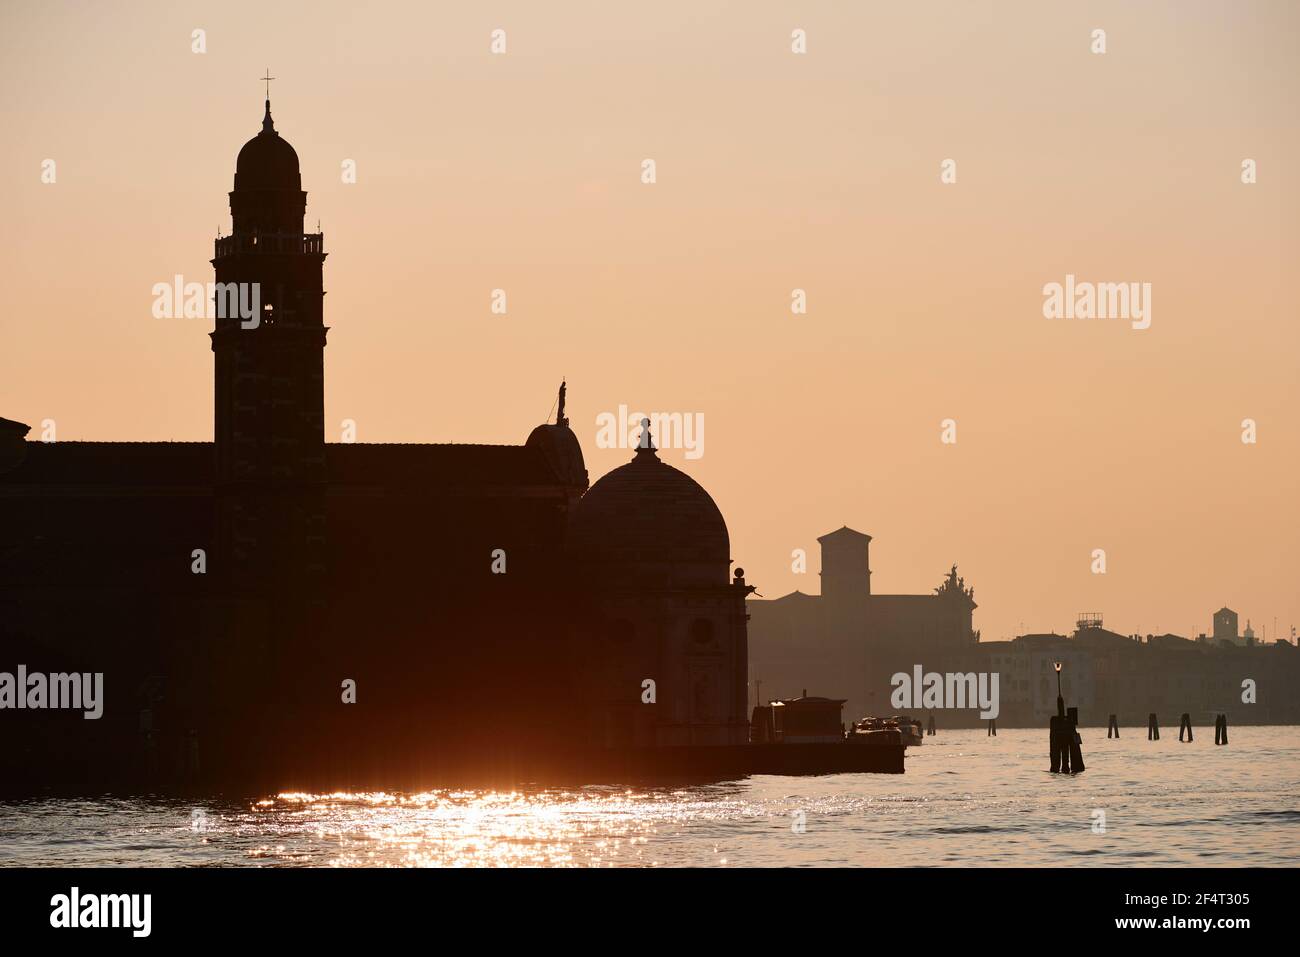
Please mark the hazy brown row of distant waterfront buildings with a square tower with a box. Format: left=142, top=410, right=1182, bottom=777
left=746, top=538, right=1300, bottom=727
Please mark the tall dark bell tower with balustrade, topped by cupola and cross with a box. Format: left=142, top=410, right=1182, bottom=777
left=212, top=96, right=328, bottom=588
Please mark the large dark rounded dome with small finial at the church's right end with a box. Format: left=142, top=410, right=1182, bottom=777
left=569, top=431, right=731, bottom=585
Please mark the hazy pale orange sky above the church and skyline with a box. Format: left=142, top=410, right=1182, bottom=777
left=0, top=0, right=1300, bottom=638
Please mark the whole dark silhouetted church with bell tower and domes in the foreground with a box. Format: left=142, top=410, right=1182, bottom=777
left=0, top=99, right=751, bottom=790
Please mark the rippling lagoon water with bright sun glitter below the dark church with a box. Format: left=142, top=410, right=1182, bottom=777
left=0, top=723, right=1300, bottom=867
